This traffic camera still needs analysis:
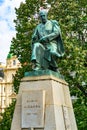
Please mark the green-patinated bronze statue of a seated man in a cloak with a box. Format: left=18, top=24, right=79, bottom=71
left=31, top=10, right=64, bottom=71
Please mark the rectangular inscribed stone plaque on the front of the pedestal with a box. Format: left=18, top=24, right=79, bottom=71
left=22, top=90, right=45, bottom=128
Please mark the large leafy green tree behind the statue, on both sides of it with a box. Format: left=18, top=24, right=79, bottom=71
left=10, top=0, right=87, bottom=129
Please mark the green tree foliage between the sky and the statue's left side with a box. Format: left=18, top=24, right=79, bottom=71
left=10, top=0, right=39, bottom=93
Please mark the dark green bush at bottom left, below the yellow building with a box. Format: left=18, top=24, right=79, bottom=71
left=0, top=102, right=15, bottom=130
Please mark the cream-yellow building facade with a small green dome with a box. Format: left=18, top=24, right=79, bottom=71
left=0, top=54, right=21, bottom=113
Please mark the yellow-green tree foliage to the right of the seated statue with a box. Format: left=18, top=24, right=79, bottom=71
left=49, top=0, right=87, bottom=96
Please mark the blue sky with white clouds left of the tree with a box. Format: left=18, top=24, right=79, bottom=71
left=0, top=0, right=25, bottom=63
